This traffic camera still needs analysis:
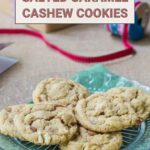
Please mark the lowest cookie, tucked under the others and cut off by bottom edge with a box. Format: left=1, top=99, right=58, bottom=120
left=60, top=127, right=122, bottom=150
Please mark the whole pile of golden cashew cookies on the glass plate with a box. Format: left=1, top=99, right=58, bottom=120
left=0, top=78, right=150, bottom=150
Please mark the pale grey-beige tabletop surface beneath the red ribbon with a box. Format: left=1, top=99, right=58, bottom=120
left=0, top=0, right=150, bottom=107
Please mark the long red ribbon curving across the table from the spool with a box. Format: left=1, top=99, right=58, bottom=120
left=0, top=25, right=135, bottom=63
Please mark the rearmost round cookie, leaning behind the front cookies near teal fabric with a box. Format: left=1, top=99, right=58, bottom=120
left=33, top=78, right=90, bottom=106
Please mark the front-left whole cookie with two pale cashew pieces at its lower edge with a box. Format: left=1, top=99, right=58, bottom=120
left=14, top=104, right=77, bottom=145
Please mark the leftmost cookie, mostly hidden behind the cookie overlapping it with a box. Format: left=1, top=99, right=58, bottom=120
left=0, top=105, right=24, bottom=139
